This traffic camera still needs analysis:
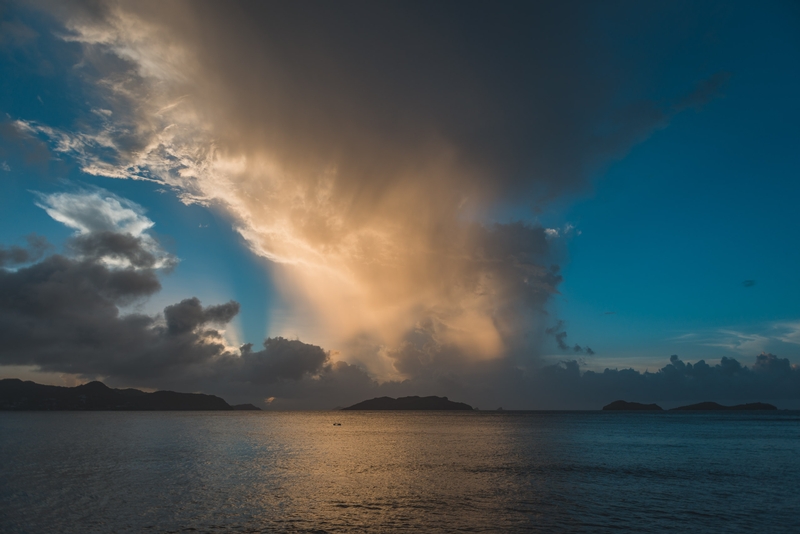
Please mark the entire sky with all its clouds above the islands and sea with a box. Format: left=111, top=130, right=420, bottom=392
left=0, top=1, right=800, bottom=409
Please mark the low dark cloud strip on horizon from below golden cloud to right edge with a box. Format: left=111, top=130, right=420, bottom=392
left=272, top=353, right=800, bottom=410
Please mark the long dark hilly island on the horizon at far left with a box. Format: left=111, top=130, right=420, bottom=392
left=0, top=378, right=260, bottom=411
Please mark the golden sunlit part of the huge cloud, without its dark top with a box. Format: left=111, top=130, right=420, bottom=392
left=20, top=6, right=576, bottom=377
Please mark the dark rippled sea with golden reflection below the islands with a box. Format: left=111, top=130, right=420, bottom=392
left=0, top=412, right=800, bottom=534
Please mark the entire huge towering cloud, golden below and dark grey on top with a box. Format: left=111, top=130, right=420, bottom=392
left=14, top=0, right=744, bottom=392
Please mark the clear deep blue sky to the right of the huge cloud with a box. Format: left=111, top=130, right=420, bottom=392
left=559, top=4, right=800, bottom=370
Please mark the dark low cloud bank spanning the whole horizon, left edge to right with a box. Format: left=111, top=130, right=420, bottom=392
left=0, top=234, right=800, bottom=409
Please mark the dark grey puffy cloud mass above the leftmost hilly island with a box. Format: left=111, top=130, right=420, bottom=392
left=0, top=237, right=328, bottom=391
